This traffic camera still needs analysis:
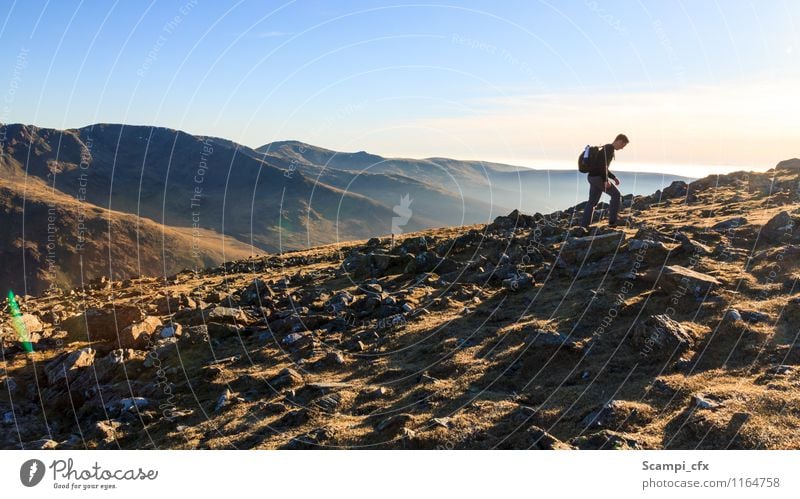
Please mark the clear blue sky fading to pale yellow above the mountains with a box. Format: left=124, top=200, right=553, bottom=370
left=0, top=0, right=800, bottom=176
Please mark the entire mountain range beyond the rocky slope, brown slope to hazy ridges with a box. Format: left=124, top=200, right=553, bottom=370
left=0, top=124, right=688, bottom=294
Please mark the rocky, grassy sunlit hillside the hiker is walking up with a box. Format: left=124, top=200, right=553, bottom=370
left=0, top=160, right=800, bottom=449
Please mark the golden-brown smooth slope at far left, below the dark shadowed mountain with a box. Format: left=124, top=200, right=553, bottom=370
left=0, top=178, right=259, bottom=295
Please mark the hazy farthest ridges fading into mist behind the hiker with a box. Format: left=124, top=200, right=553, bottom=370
left=256, top=141, right=692, bottom=215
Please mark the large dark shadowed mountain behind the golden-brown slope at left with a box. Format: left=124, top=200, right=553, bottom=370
left=3, top=124, right=393, bottom=251
